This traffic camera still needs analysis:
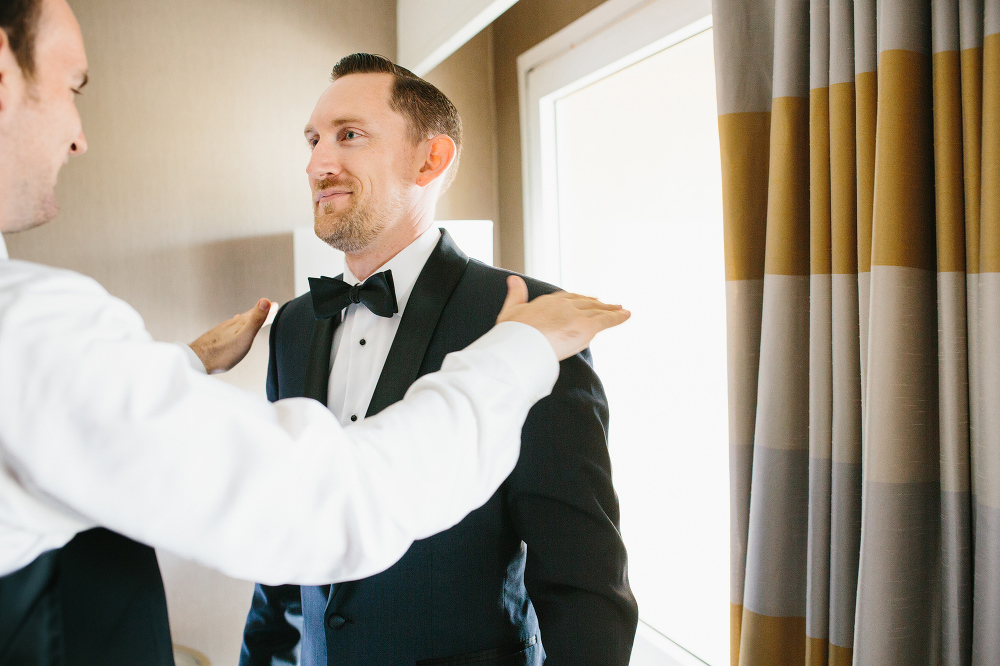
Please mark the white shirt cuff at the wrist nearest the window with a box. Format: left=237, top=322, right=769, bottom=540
left=467, top=321, right=559, bottom=402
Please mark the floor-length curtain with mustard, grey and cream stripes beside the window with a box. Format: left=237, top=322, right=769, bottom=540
left=713, top=0, right=1000, bottom=666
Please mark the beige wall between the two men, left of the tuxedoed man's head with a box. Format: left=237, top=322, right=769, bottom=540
left=6, top=0, right=396, bottom=666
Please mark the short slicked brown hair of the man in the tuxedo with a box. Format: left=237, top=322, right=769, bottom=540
left=330, top=53, right=462, bottom=189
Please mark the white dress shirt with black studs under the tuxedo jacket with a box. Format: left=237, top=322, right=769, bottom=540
left=327, top=225, right=441, bottom=426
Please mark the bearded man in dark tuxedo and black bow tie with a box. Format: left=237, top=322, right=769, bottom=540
left=241, top=54, right=638, bottom=666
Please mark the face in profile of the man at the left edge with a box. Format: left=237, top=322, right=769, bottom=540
left=0, top=0, right=87, bottom=232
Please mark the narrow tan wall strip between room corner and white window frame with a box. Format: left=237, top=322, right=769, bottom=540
left=493, top=0, right=604, bottom=271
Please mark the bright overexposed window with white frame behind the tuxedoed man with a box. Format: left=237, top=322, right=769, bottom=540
left=519, top=0, right=729, bottom=666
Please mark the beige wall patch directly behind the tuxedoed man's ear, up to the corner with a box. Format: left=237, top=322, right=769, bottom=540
left=426, top=26, right=500, bottom=262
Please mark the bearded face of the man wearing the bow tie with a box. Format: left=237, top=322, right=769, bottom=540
left=305, top=74, right=417, bottom=253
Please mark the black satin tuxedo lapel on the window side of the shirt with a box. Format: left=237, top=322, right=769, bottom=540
left=367, top=229, right=469, bottom=416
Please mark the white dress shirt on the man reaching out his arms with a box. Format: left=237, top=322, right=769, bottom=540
left=0, top=232, right=558, bottom=584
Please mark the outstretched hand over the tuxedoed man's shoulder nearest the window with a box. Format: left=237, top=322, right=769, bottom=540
left=497, top=275, right=632, bottom=361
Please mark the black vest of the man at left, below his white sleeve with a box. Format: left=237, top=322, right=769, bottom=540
left=0, top=528, right=174, bottom=666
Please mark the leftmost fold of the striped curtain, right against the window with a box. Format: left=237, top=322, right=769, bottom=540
left=713, top=0, right=774, bottom=663
